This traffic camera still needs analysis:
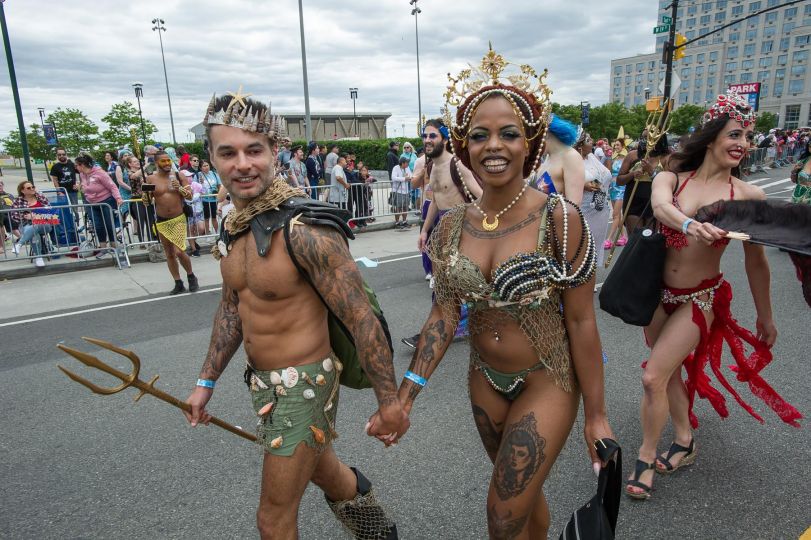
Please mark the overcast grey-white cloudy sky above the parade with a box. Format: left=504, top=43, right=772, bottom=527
left=0, top=0, right=657, bottom=142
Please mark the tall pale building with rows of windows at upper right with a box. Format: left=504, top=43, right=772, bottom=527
left=609, top=0, right=811, bottom=129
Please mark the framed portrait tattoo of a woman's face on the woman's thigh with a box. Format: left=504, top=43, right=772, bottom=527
left=493, top=412, right=546, bottom=501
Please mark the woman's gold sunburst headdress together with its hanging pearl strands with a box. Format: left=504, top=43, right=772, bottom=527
left=442, top=44, right=552, bottom=173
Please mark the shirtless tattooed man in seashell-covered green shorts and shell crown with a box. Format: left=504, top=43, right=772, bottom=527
left=186, top=88, right=409, bottom=539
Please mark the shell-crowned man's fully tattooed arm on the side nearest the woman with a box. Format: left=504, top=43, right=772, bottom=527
left=290, top=226, right=397, bottom=407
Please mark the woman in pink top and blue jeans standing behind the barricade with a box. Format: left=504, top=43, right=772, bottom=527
left=76, top=152, right=123, bottom=258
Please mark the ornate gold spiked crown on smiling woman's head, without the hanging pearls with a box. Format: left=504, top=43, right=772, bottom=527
left=442, top=44, right=552, bottom=135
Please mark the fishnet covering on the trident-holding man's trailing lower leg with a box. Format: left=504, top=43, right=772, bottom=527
left=327, top=467, right=397, bottom=540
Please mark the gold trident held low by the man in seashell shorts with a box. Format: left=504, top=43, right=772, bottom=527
left=56, top=337, right=257, bottom=442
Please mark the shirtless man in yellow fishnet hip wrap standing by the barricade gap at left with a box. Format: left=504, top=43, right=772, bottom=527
left=141, top=151, right=200, bottom=294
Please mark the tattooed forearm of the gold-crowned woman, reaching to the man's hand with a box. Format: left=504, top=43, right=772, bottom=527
left=400, top=304, right=456, bottom=411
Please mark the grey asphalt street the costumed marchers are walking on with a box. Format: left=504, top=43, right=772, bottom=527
left=0, top=167, right=811, bottom=539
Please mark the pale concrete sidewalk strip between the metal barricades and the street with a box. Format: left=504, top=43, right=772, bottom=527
left=0, top=221, right=422, bottom=321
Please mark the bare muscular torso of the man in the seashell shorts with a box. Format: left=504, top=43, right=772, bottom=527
left=220, top=225, right=330, bottom=370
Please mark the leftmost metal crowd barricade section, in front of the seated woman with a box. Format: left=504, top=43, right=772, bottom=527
left=0, top=201, right=129, bottom=270
